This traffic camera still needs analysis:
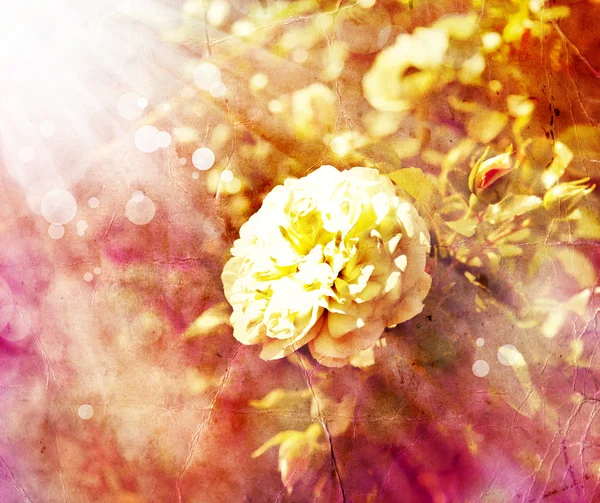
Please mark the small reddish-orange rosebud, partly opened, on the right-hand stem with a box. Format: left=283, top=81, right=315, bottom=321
left=469, top=149, right=515, bottom=204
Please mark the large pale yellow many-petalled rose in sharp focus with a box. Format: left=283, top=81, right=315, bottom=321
left=222, top=166, right=431, bottom=366
